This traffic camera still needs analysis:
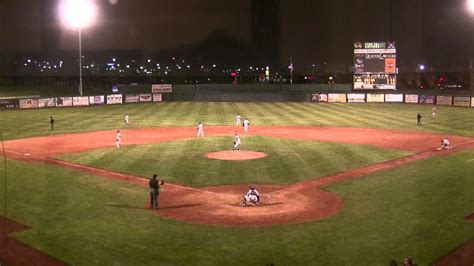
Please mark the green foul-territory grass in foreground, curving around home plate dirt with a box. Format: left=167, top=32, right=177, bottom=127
left=0, top=147, right=474, bottom=265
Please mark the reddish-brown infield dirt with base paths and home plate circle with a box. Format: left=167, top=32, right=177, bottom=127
left=5, top=126, right=474, bottom=226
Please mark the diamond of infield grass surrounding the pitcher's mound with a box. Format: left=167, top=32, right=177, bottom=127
left=57, top=136, right=410, bottom=186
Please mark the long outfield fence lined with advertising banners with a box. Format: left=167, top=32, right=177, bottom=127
left=0, top=91, right=474, bottom=109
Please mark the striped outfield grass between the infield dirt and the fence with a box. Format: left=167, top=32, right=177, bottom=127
left=0, top=102, right=474, bottom=139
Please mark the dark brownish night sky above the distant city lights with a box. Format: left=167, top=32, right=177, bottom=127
left=0, top=0, right=474, bottom=68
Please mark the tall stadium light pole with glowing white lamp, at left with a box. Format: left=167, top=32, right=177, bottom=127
left=58, top=0, right=97, bottom=96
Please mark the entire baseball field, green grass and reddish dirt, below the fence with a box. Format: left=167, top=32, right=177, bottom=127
left=0, top=102, right=474, bottom=265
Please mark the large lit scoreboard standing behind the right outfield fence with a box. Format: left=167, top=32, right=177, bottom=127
left=354, top=42, right=397, bottom=90
